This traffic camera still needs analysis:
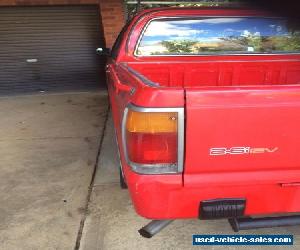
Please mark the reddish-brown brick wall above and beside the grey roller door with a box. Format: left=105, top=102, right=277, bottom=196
left=0, top=0, right=125, bottom=47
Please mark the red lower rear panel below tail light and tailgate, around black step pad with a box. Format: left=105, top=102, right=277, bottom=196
left=125, top=168, right=300, bottom=219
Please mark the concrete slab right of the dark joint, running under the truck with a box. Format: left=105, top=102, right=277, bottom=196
left=81, top=115, right=300, bottom=250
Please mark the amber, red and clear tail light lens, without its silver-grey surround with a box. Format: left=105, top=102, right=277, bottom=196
left=124, top=106, right=184, bottom=175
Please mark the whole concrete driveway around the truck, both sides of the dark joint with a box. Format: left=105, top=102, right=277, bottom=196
left=0, top=93, right=300, bottom=250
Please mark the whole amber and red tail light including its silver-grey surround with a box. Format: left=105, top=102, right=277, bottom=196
left=123, top=105, right=184, bottom=174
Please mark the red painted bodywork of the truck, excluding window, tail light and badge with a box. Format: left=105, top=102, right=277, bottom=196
left=107, top=8, right=300, bottom=219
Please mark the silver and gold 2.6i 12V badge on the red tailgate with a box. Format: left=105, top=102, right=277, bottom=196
left=209, top=147, right=278, bottom=156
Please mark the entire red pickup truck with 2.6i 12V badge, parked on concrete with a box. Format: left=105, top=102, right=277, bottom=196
left=103, top=8, right=300, bottom=237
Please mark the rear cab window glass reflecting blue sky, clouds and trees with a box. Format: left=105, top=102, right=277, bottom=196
left=136, top=17, right=300, bottom=56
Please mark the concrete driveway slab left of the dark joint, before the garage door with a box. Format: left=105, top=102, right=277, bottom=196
left=0, top=92, right=107, bottom=250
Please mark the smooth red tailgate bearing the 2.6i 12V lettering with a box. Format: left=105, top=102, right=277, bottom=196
left=184, top=86, right=300, bottom=185
